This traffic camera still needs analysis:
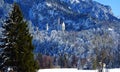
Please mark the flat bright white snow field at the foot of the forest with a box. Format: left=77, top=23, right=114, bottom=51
left=38, top=68, right=120, bottom=72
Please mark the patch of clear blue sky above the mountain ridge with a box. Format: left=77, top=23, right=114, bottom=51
left=94, top=0, right=120, bottom=16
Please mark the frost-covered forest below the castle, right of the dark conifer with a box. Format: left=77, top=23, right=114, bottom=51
left=33, top=28, right=119, bottom=69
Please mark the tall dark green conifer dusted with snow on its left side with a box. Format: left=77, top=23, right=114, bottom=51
left=0, top=3, right=36, bottom=72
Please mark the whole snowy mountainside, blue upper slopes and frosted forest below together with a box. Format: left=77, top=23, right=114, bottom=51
left=0, top=0, right=120, bottom=69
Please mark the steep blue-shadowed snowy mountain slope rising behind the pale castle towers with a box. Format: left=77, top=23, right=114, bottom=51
left=0, top=0, right=118, bottom=31
